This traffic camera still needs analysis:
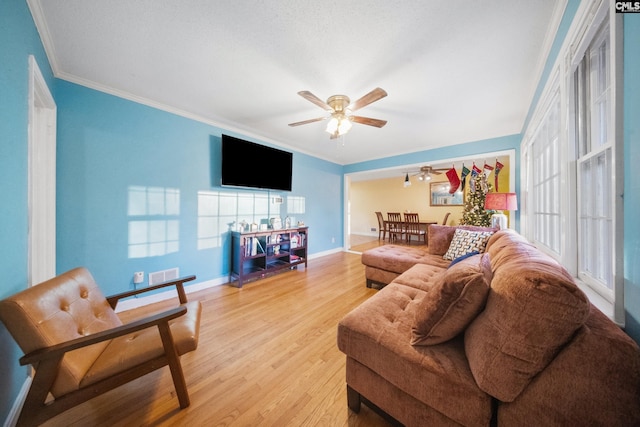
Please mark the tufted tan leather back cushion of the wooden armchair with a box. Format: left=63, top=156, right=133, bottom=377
left=0, top=268, right=122, bottom=396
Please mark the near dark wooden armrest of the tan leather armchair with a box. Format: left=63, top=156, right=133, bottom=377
left=20, top=306, right=187, bottom=365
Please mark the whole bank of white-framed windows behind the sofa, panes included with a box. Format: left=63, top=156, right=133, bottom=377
left=521, top=0, right=624, bottom=324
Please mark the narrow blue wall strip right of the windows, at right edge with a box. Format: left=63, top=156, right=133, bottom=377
left=624, top=14, right=640, bottom=342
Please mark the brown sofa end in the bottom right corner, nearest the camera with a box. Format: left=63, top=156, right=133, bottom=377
left=498, top=305, right=640, bottom=426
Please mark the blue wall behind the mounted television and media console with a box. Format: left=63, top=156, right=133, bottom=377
left=55, top=81, right=343, bottom=294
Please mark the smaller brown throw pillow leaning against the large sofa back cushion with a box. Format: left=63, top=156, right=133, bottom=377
left=411, top=254, right=491, bottom=345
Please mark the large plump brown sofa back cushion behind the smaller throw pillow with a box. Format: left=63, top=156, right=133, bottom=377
left=465, top=233, right=590, bottom=402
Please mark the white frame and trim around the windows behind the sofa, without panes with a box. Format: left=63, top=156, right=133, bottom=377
left=521, top=0, right=624, bottom=326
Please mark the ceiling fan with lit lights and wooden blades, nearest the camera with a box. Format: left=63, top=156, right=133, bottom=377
left=289, top=87, right=387, bottom=139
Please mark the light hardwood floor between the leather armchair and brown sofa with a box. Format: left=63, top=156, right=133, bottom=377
left=40, top=244, right=398, bottom=427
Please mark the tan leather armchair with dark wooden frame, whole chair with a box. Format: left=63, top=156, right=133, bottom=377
left=0, top=268, right=201, bottom=425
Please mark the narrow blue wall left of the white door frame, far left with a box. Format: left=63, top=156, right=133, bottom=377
left=0, top=0, right=53, bottom=420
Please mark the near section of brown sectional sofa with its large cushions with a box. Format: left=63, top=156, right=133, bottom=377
left=338, top=230, right=640, bottom=426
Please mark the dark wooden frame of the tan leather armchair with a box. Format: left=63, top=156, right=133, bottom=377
left=12, top=276, right=196, bottom=426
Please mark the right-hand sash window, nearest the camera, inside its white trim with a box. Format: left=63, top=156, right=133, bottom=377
left=572, top=22, right=615, bottom=302
